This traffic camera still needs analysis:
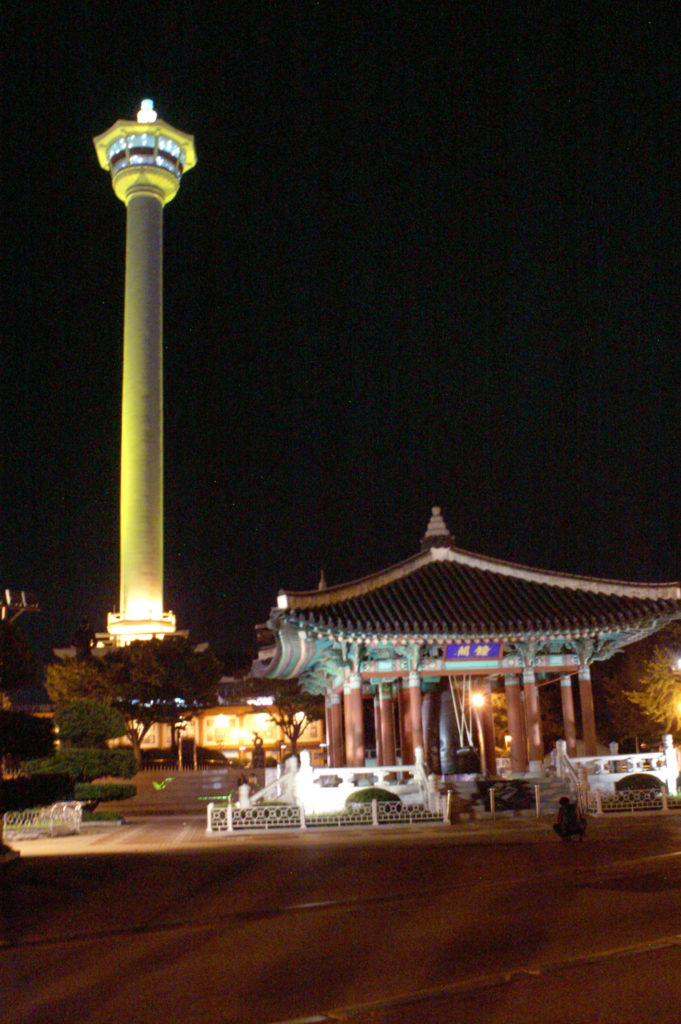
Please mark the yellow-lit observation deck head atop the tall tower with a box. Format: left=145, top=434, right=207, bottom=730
left=94, top=99, right=197, bottom=205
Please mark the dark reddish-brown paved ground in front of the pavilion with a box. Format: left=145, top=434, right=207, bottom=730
left=0, top=815, right=681, bottom=1024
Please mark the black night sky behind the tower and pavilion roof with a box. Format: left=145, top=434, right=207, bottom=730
left=0, top=0, right=681, bottom=654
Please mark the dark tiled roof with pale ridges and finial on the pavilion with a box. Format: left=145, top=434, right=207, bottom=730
left=278, top=509, right=681, bottom=639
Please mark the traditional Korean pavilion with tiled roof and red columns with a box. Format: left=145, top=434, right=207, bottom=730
left=253, top=507, right=681, bottom=773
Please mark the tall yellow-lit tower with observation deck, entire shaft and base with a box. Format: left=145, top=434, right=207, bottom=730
left=93, top=99, right=197, bottom=646
